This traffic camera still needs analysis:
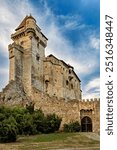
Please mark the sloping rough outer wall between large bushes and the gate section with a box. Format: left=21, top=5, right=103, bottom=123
left=32, top=88, right=80, bottom=127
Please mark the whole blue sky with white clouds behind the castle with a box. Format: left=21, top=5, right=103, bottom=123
left=0, top=0, right=100, bottom=98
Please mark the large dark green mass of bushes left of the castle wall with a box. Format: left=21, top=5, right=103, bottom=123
left=0, top=103, right=61, bottom=142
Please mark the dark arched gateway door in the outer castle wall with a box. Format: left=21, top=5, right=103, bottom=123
left=81, top=116, right=92, bottom=132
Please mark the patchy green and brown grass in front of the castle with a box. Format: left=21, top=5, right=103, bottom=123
left=0, top=133, right=99, bottom=150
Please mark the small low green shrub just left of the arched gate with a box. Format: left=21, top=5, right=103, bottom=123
left=63, top=121, right=81, bottom=132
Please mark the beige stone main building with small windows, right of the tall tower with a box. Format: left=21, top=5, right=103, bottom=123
left=44, top=55, right=82, bottom=100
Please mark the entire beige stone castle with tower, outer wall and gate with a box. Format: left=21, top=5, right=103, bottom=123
left=0, top=15, right=100, bottom=132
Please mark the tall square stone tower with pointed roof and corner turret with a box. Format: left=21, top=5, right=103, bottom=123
left=9, top=15, right=48, bottom=96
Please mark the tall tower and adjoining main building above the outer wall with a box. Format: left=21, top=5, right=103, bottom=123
left=9, top=15, right=82, bottom=100
